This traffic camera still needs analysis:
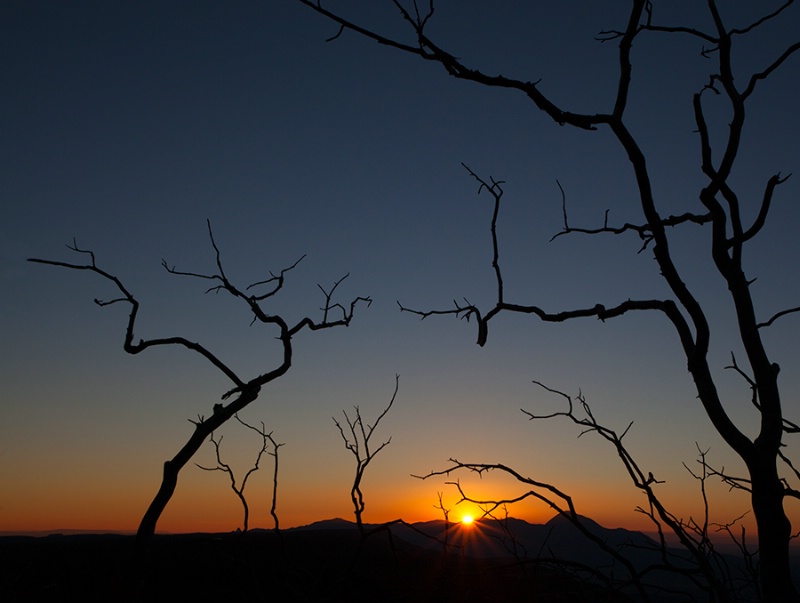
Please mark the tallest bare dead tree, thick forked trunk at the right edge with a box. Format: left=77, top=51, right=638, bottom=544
left=298, top=0, right=800, bottom=601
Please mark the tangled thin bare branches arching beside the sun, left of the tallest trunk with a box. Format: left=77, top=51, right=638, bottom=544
left=416, top=382, right=755, bottom=602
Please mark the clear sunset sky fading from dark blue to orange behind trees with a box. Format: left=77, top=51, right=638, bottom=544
left=0, top=0, right=800, bottom=532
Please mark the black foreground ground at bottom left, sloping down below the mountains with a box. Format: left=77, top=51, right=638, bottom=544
left=0, top=530, right=632, bottom=603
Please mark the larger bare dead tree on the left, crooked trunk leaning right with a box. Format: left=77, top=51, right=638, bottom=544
left=29, top=222, right=371, bottom=550
